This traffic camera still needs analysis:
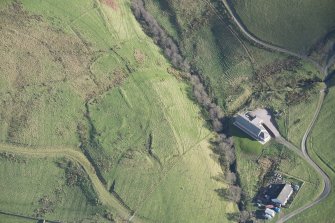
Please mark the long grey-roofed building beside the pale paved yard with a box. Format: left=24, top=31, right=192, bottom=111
left=234, top=113, right=271, bottom=144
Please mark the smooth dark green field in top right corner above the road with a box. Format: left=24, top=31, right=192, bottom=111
left=231, top=0, right=335, bottom=52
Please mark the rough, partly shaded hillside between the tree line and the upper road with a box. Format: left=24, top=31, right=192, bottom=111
left=145, top=0, right=320, bottom=114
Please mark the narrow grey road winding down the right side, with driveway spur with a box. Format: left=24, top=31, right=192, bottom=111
left=222, top=0, right=335, bottom=223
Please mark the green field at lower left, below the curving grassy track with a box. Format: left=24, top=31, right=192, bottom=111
left=0, top=153, right=104, bottom=222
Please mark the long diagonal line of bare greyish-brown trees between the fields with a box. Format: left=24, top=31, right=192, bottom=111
left=132, top=0, right=241, bottom=203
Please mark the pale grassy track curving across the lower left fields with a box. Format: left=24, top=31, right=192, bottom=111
left=0, top=143, right=140, bottom=222
